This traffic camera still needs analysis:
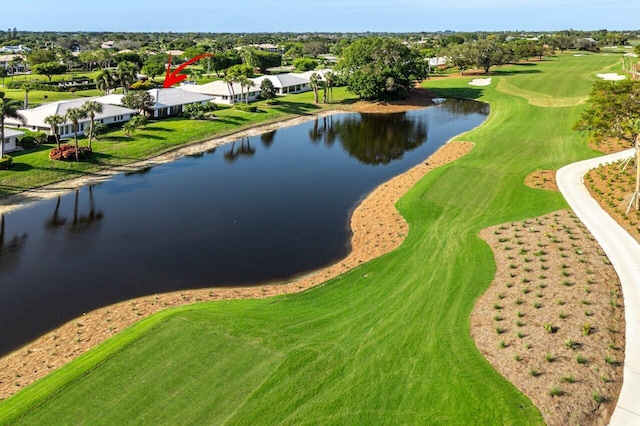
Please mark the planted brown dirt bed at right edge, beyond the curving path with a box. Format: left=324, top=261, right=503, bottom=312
left=584, top=160, right=640, bottom=243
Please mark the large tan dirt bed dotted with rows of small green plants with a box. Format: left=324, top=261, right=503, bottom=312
left=471, top=211, right=625, bottom=425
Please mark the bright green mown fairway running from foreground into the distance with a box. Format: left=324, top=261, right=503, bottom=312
left=0, top=55, right=620, bottom=425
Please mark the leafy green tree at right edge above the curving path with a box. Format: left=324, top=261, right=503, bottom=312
left=574, top=80, right=640, bottom=213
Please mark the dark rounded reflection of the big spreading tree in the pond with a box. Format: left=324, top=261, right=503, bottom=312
left=332, top=113, right=428, bottom=165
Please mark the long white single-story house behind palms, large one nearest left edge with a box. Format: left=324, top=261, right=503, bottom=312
left=5, top=98, right=138, bottom=137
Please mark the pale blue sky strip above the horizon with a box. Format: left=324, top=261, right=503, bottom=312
left=0, top=0, right=640, bottom=32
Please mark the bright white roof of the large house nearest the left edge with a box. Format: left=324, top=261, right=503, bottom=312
left=5, top=98, right=137, bottom=127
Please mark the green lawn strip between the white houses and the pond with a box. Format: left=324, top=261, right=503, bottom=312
left=0, top=88, right=354, bottom=196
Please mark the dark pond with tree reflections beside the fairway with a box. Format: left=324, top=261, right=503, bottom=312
left=0, top=100, right=488, bottom=354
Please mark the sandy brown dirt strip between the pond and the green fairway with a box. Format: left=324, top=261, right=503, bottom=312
left=0, top=142, right=473, bottom=399
